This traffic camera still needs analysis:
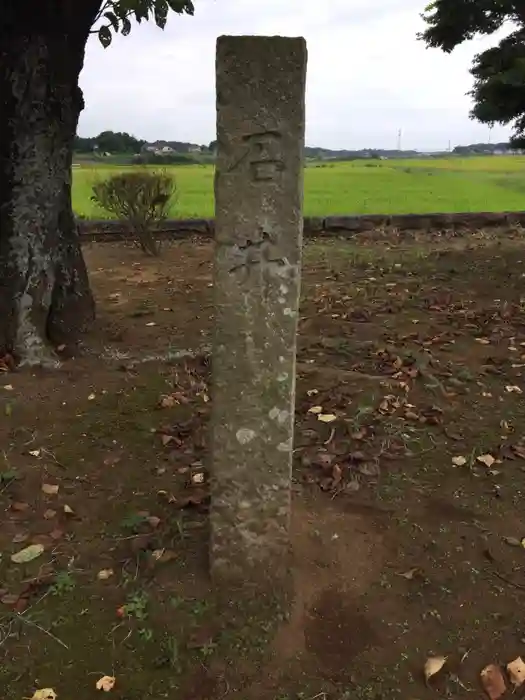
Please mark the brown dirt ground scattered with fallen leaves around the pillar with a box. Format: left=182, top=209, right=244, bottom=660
left=0, top=231, right=525, bottom=700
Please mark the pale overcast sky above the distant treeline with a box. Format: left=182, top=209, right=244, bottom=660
left=79, top=0, right=509, bottom=150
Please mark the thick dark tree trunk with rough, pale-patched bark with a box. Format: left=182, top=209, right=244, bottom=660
left=0, top=0, right=101, bottom=365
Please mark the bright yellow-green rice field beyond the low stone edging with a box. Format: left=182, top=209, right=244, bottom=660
left=73, top=156, right=525, bottom=219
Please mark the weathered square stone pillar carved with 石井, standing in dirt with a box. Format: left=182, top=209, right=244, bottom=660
left=210, top=36, right=306, bottom=590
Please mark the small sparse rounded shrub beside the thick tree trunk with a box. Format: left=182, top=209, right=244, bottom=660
left=91, top=169, right=177, bottom=255
